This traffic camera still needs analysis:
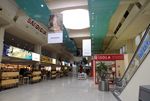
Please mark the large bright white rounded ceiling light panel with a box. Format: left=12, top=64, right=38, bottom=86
left=62, top=9, right=90, bottom=29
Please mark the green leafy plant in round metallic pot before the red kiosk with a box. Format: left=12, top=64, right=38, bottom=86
left=96, top=62, right=109, bottom=91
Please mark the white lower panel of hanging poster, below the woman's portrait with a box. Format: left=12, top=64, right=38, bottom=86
left=48, top=32, right=63, bottom=44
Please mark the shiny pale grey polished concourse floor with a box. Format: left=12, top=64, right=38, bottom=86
left=0, top=78, right=117, bottom=101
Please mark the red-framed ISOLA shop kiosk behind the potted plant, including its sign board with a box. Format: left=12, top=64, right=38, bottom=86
left=92, top=54, right=125, bottom=85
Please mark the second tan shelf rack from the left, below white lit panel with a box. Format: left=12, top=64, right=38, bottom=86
left=31, top=71, right=41, bottom=83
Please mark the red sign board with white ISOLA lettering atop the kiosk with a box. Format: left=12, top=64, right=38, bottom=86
left=94, top=54, right=124, bottom=61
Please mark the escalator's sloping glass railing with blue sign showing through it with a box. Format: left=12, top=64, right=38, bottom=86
left=114, top=25, right=150, bottom=95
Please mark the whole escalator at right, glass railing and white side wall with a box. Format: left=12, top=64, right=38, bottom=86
left=113, top=25, right=150, bottom=101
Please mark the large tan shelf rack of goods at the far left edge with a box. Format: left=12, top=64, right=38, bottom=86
left=0, top=64, right=19, bottom=89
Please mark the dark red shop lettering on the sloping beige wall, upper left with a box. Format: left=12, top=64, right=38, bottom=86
left=27, top=18, right=46, bottom=35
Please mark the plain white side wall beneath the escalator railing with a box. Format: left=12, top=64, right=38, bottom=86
left=119, top=54, right=150, bottom=101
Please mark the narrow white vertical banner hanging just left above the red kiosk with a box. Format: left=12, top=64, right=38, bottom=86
left=82, top=39, right=91, bottom=56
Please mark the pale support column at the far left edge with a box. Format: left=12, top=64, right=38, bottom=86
left=0, top=27, right=5, bottom=63
